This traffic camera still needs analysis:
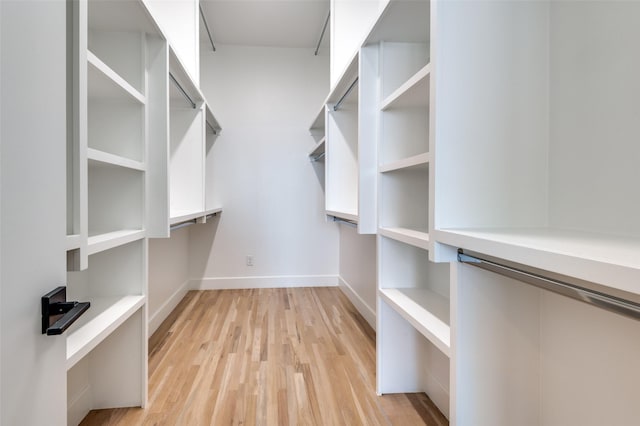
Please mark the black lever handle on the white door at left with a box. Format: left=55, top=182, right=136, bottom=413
left=41, top=286, right=91, bottom=336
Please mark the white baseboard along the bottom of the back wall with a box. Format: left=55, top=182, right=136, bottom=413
left=191, top=275, right=338, bottom=290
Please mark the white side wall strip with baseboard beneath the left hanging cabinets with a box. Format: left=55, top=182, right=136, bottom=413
left=148, top=225, right=190, bottom=336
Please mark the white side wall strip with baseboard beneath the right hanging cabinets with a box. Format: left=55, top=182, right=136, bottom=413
left=340, top=224, right=376, bottom=329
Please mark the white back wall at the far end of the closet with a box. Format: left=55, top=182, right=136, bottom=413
left=189, top=45, right=338, bottom=288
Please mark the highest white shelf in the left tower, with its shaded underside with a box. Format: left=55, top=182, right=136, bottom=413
left=87, top=51, right=146, bottom=104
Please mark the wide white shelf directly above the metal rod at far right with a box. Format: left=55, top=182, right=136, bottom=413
left=432, top=228, right=640, bottom=294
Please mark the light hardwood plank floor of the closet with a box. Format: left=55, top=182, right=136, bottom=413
left=82, top=288, right=448, bottom=426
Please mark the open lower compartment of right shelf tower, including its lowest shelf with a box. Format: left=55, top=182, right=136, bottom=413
left=376, top=236, right=451, bottom=415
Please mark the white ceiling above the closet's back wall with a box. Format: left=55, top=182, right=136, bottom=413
left=200, top=0, right=329, bottom=51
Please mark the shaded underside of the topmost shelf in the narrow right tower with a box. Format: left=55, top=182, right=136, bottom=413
left=363, top=0, right=431, bottom=45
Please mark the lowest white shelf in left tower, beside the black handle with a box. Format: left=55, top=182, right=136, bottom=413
left=67, top=295, right=145, bottom=370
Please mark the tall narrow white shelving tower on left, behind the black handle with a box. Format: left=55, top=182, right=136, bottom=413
left=64, top=0, right=161, bottom=425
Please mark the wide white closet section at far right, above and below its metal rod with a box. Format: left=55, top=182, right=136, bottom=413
left=430, top=1, right=640, bottom=425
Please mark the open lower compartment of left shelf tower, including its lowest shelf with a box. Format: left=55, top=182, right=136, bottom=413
left=66, top=239, right=147, bottom=424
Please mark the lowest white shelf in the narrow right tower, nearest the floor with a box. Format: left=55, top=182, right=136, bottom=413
left=379, top=288, right=451, bottom=357
